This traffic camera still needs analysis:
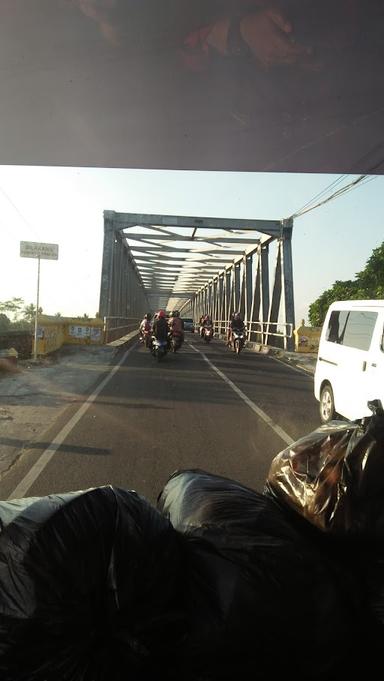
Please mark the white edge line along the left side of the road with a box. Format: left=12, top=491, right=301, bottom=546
left=8, top=343, right=136, bottom=499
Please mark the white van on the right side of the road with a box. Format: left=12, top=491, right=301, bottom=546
left=315, top=300, right=384, bottom=423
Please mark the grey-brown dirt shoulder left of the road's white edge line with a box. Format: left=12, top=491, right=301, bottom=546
left=0, top=346, right=117, bottom=478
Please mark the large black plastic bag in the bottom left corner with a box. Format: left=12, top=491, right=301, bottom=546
left=0, top=487, right=180, bottom=681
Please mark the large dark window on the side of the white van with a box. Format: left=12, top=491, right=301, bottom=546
left=326, top=310, right=377, bottom=350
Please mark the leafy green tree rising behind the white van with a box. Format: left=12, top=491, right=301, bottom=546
left=308, top=242, right=384, bottom=326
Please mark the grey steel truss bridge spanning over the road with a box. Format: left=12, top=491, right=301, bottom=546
left=99, top=211, right=295, bottom=350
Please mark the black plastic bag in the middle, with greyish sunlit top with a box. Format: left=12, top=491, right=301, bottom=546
left=158, top=470, right=362, bottom=681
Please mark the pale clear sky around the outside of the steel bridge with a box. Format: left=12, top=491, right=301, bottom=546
left=0, top=166, right=384, bottom=324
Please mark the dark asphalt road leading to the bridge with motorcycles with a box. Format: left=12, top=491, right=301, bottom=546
left=0, top=334, right=320, bottom=502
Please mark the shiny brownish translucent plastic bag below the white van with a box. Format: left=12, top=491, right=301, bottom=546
left=265, top=403, right=384, bottom=539
